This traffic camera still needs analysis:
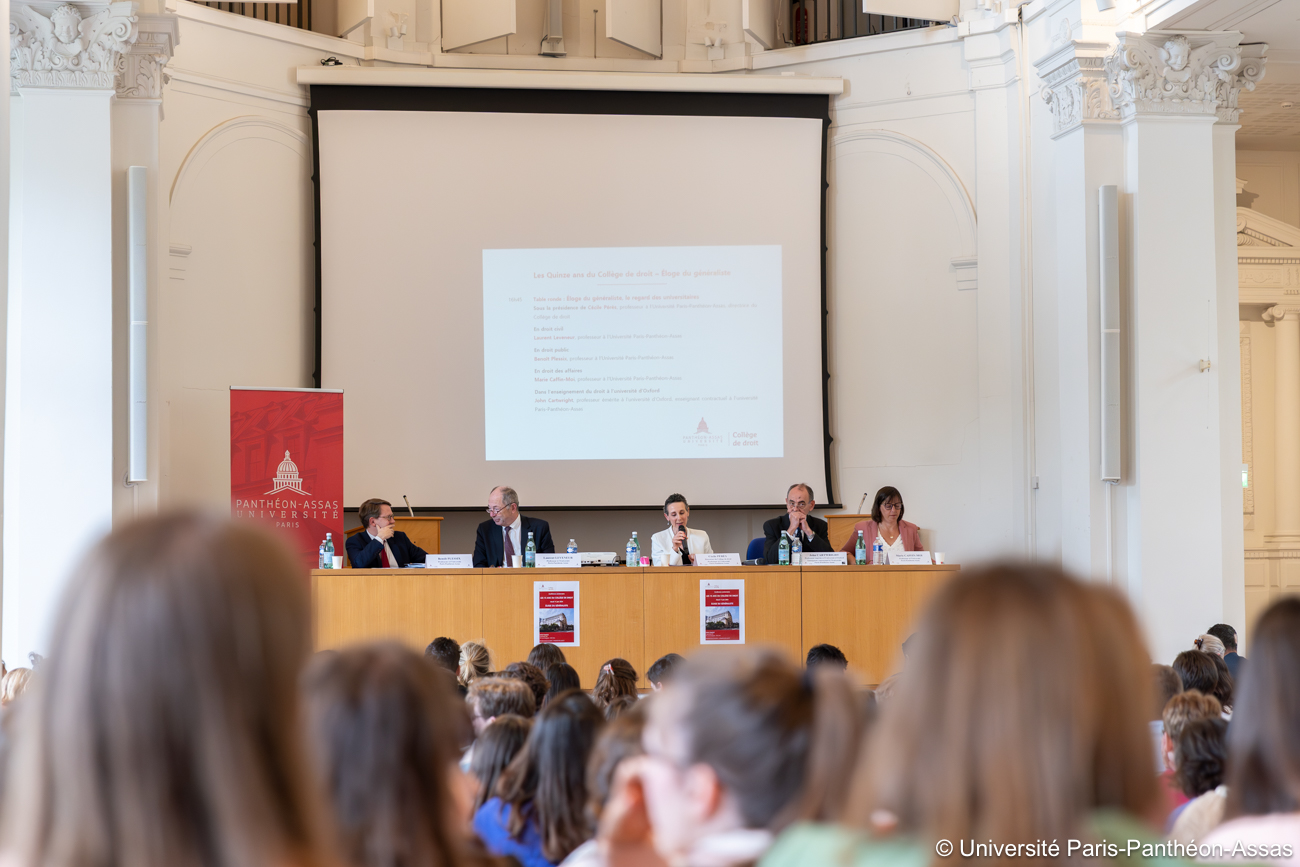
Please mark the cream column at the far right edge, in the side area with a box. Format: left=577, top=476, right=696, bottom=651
left=1264, top=307, right=1300, bottom=545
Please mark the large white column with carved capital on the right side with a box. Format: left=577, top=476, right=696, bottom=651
left=1106, top=31, right=1262, bottom=662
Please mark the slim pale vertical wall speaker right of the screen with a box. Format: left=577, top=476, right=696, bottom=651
left=1097, top=185, right=1123, bottom=482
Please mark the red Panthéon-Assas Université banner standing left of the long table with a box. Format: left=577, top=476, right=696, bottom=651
left=230, top=387, right=343, bottom=569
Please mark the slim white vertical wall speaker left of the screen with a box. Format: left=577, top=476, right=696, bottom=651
left=126, top=165, right=150, bottom=484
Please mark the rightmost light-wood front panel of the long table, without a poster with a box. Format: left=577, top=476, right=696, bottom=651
left=803, top=565, right=961, bottom=685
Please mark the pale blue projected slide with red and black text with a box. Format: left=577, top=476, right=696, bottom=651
left=482, top=244, right=774, bottom=460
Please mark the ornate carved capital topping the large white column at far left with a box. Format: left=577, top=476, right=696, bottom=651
left=9, top=1, right=138, bottom=88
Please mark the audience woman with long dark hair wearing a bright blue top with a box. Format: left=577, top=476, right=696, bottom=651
left=473, top=692, right=605, bottom=867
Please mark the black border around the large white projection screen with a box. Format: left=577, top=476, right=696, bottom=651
left=307, top=83, right=844, bottom=511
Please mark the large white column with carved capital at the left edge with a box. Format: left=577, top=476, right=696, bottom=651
left=0, top=3, right=137, bottom=666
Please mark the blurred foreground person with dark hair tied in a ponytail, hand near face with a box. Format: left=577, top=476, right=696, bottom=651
left=601, top=649, right=859, bottom=867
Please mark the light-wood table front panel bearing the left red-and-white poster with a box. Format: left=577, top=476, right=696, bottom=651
left=482, top=567, right=646, bottom=689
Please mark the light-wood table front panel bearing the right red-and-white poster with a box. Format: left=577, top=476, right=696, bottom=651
left=637, top=565, right=803, bottom=688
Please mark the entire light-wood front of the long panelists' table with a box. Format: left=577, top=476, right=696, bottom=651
left=312, top=565, right=961, bottom=689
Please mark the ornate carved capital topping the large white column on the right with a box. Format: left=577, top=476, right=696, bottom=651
left=1106, top=31, right=1265, bottom=122
